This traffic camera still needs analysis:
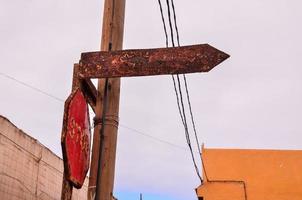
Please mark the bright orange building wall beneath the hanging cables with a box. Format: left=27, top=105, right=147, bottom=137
left=197, top=149, right=302, bottom=200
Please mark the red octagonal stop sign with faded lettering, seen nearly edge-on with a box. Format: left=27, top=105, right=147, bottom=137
left=61, top=89, right=90, bottom=188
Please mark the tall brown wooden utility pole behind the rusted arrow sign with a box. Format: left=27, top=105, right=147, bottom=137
left=88, top=0, right=126, bottom=200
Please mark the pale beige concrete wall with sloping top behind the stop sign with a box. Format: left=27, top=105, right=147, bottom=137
left=0, top=116, right=88, bottom=200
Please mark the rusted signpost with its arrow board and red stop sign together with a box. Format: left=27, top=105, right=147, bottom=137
left=61, top=44, right=229, bottom=199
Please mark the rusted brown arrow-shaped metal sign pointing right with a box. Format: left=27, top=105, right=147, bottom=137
left=78, top=44, right=229, bottom=79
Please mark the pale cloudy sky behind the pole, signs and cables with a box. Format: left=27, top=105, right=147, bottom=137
left=0, top=0, right=302, bottom=200
